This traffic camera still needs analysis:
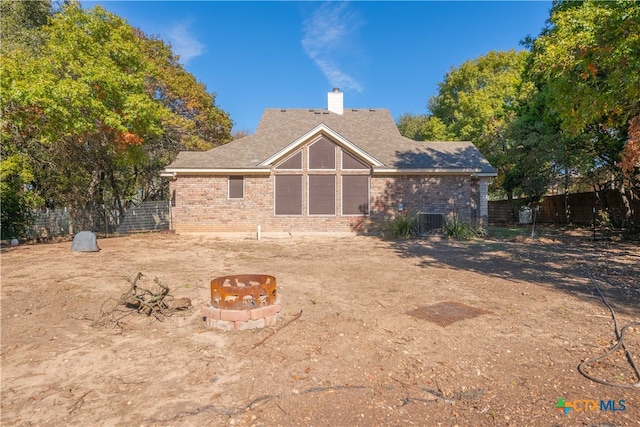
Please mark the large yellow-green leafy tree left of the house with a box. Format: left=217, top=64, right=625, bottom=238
left=0, top=2, right=231, bottom=232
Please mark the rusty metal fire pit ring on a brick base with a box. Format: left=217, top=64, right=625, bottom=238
left=202, top=274, right=280, bottom=331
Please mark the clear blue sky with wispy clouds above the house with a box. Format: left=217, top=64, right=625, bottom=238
left=82, top=1, right=551, bottom=132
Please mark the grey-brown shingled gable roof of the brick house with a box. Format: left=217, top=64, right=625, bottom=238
left=165, top=109, right=496, bottom=176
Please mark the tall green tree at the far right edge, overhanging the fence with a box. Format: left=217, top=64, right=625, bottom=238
left=532, top=0, right=640, bottom=226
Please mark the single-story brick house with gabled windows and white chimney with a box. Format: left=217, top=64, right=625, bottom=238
left=162, top=89, right=496, bottom=234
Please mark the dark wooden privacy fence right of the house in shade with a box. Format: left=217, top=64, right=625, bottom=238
left=489, top=190, right=640, bottom=226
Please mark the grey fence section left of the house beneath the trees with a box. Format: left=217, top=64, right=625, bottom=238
left=24, top=200, right=171, bottom=241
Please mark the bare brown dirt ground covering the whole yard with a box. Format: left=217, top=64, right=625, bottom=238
left=0, top=230, right=640, bottom=426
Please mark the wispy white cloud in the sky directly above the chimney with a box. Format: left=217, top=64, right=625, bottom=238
left=302, top=2, right=363, bottom=92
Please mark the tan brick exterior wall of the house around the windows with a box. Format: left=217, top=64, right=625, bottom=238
left=170, top=173, right=480, bottom=233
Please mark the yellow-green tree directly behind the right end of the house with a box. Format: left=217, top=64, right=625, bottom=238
left=428, top=50, right=539, bottom=197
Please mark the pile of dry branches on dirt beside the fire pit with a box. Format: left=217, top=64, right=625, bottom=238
left=93, top=272, right=192, bottom=329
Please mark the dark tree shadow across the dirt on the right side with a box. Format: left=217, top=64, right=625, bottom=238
left=392, top=231, right=640, bottom=317
